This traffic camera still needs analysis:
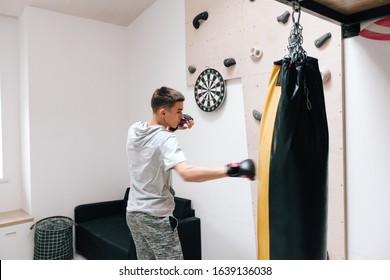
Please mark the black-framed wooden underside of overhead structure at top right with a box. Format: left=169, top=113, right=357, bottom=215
left=276, top=0, right=390, bottom=25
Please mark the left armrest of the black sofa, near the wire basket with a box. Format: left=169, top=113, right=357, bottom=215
left=74, top=199, right=123, bottom=224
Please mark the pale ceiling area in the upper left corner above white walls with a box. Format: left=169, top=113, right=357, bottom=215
left=0, top=0, right=155, bottom=26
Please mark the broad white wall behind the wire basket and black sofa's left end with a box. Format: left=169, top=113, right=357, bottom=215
left=20, top=7, right=131, bottom=220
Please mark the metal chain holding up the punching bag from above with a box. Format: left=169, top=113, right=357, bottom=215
left=287, top=1, right=307, bottom=62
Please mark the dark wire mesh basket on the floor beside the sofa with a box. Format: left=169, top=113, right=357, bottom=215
left=31, top=216, right=74, bottom=260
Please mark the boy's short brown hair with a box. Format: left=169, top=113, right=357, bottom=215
left=151, top=87, right=185, bottom=113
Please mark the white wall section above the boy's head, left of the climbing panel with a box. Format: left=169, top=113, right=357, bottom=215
left=127, top=0, right=186, bottom=120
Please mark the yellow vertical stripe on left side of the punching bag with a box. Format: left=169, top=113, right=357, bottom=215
left=257, top=64, right=281, bottom=260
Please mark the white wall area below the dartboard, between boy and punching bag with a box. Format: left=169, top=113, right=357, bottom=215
left=175, top=79, right=257, bottom=260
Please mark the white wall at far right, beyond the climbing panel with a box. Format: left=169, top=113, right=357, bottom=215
left=344, top=36, right=390, bottom=260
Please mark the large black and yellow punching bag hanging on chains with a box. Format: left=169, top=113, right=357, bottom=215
left=258, top=57, right=329, bottom=260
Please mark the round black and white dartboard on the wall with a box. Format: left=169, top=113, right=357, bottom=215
left=194, top=68, right=225, bottom=112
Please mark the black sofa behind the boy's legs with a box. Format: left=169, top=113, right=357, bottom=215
left=74, top=188, right=202, bottom=260
